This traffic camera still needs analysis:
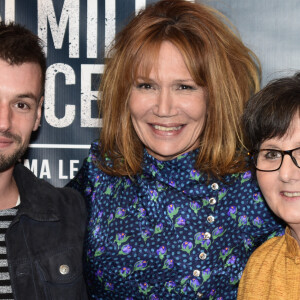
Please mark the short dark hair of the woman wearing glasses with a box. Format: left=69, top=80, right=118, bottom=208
left=242, top=72, right=300, bottom=151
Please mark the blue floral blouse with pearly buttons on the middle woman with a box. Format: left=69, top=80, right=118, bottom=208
left=69, top=143, right=283, bottom=300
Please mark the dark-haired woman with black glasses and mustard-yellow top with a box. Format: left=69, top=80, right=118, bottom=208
left=238, top=73, right=300, bottom=300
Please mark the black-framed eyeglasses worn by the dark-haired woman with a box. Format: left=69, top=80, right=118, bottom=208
left=251, top=147, right=300, bottom=172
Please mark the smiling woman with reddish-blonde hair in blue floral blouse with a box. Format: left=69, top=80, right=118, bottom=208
left=71, top=0, right=279, bottom=300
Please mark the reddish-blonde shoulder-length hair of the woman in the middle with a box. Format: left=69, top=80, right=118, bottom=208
left=99, top=0, right=260, bottom=177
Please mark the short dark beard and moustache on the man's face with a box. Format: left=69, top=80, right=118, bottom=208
left=0, top=132, right=27, bottom=172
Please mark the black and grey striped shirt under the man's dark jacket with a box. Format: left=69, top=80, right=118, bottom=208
left=0, top=207, right=18, bottom=300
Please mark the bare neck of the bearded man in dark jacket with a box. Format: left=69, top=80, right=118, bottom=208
left=0, top=167, right=19, bottom=210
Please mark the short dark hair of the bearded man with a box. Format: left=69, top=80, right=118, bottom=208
left=0, top=21, right=46, bottom=93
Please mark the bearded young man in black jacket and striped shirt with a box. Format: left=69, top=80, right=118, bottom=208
left=0, top=22, right=87, bottom=300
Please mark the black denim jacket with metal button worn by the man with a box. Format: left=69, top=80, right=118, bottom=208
left=5, top=164, right=87, bottom=300
